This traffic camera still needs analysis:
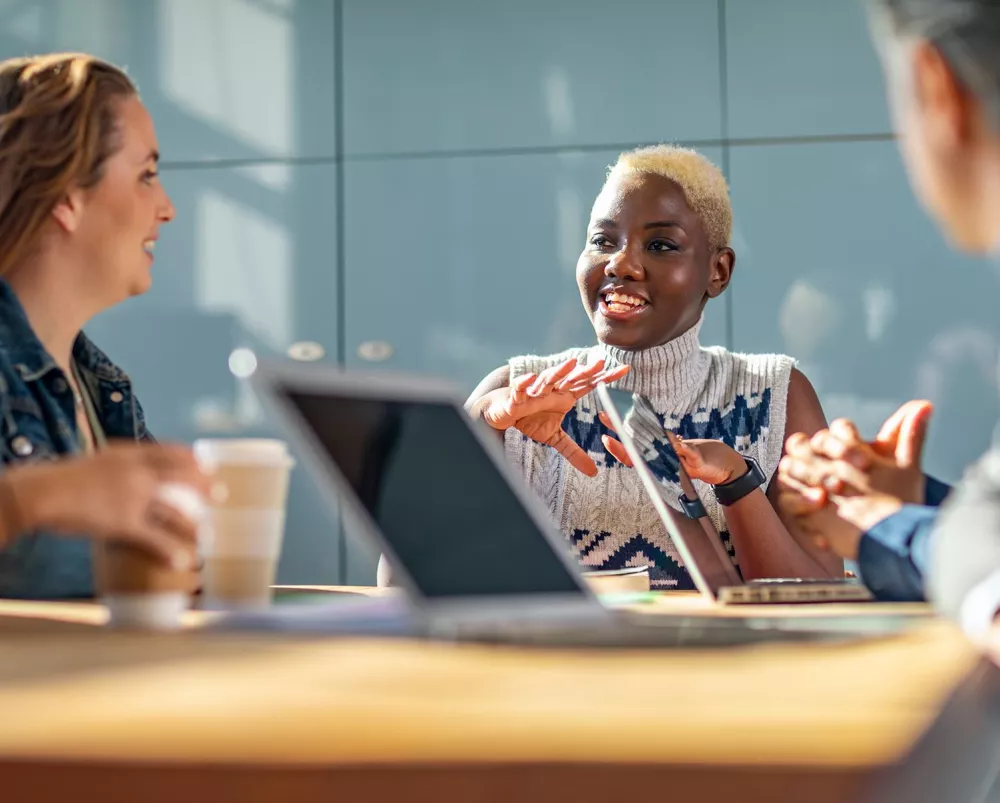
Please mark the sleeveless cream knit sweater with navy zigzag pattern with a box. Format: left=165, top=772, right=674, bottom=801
left=505, top=323, right=794, bottom=589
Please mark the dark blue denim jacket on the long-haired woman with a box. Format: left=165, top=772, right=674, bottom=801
left=0, top=280, right=151, bottom=599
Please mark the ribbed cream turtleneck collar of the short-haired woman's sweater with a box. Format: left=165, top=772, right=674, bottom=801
left=597, top=318, right=712, bottom=409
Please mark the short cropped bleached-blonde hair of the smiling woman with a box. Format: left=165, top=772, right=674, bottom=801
left=605, top=145, right=733, bottom=249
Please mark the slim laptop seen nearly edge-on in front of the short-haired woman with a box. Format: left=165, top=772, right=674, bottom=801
left=597, top=385, right=874, bottom=605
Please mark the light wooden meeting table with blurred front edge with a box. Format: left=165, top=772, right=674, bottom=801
left=0, top=594, right=977, bottom=803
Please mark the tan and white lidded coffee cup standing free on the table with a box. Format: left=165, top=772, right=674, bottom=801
left=194, top=438, right=294, bottom=610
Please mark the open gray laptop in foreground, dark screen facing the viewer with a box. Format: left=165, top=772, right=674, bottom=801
left=240, top=363, right=900, bottom=646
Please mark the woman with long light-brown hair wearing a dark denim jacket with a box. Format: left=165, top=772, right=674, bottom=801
left=0, top=53, right=190, bottom=598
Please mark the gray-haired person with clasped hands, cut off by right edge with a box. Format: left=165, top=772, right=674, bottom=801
left=779, top=0, right=1000, bottom=637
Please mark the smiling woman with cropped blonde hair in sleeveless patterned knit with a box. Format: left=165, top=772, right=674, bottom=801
left=469, top=145, right=843, bottom=589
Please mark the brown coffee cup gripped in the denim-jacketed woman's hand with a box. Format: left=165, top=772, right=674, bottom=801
left=92, top=483, right=207, bottom=630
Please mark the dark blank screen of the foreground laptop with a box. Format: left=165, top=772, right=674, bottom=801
left=281, top=387, right=582, bottom=598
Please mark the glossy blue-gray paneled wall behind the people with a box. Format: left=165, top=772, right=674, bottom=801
left=0, top=0, right=1000, bottom=583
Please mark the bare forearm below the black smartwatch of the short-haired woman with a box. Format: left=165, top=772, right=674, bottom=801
left=725, top=488, right=843, bottom=580
